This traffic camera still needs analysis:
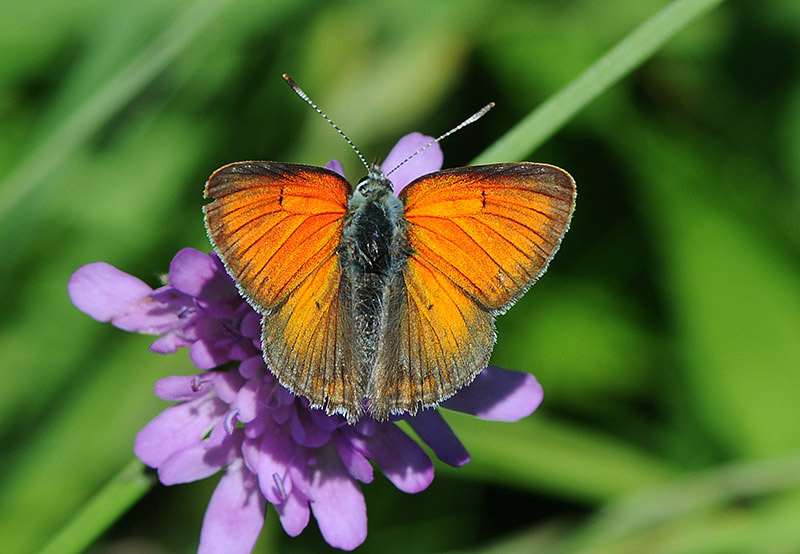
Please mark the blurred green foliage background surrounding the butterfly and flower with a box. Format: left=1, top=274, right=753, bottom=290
left=0, top=0, right=800, bottom=553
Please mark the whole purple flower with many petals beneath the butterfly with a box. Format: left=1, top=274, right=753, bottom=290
left=69, top=133, right=542, bottom=554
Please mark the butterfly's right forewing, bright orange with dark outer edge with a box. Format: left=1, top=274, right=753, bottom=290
left=401, top=163, right=575, bottom=311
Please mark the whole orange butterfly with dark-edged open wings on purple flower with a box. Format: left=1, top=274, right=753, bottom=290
left=204, top=78, right=576, bottom=423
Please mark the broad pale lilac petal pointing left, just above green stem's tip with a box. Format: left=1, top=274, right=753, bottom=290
left=133, top=397, right=227, bottom=467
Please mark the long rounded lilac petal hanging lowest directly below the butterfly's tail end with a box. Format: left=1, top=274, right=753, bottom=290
left=311, top=446, right=367, bottom=550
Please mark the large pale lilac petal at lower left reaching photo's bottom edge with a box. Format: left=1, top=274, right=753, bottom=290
left=197, top=459, right=266, bottom=554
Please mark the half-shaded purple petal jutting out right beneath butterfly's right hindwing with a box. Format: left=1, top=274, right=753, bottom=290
left=441, top=366, right=544, bottom=421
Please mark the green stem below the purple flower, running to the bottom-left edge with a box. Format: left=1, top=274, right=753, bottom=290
left=39, top=459, right=155, bottom=554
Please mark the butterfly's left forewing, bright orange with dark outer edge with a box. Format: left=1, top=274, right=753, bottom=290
left=204, top=162, right=350, bottom=306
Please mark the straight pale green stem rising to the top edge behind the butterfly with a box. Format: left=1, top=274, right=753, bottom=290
left=472, top=0, right=723, bottom=164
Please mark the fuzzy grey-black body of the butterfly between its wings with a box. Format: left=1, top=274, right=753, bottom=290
left=340, top=165, right=410, bottom=375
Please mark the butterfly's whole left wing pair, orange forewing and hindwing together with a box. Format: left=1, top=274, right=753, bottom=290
left=204, top=162, right=360, bottom=414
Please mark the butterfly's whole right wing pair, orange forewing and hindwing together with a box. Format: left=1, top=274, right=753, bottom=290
left=369, top=163, right=575, bottom=416
